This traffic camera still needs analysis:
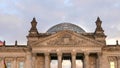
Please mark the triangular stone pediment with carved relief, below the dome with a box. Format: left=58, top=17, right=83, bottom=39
left=32, top=31, right=104, bottom=46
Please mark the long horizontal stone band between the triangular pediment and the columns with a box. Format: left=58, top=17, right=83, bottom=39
left=32, top=46, right=101, bottom=53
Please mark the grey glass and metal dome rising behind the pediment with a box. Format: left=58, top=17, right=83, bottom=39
left=47, top=23, right=85, bottom=33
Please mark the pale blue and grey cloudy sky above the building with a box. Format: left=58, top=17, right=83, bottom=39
left=0, top=0, right=120, bottom=44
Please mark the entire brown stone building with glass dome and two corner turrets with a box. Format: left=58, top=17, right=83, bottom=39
left=0, top=17, right=120, bottom=68
